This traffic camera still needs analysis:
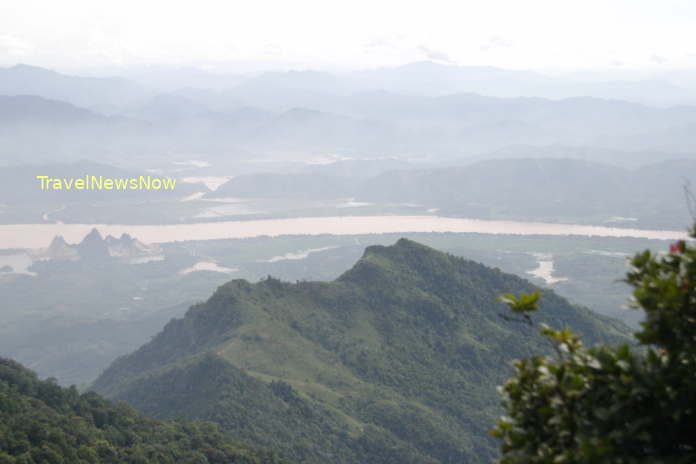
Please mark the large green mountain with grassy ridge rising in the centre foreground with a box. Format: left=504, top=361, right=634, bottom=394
left=93, top=239, right=626, bottom=464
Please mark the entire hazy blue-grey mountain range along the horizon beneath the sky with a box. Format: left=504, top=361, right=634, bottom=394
left=0, top=62, right=696, bottom=163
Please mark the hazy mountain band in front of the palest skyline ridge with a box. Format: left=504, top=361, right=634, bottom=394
left=0, top=81, right=696, bottom=163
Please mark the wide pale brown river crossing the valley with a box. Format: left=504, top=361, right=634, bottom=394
left=0, top=216, right=686, bottom=249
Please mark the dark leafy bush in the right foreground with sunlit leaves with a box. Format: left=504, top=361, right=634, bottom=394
left=491, top=225, right=696, bottom=464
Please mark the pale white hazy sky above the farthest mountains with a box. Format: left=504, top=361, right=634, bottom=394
left=0, top=0, right=696, bottom=70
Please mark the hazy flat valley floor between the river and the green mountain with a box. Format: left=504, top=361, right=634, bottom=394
left=0, top=229, right=665, bottom=386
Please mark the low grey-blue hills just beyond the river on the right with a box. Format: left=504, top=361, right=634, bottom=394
left=207, top=158, right=696, bottom=228
